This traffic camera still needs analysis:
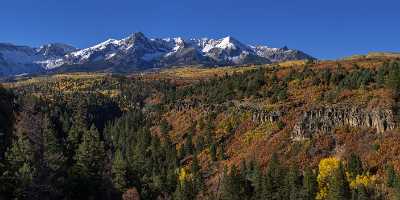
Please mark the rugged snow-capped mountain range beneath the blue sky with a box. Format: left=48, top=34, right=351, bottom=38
left=0, top=32, right=314, bottom=76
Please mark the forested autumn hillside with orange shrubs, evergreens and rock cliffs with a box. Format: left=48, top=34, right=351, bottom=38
left=0, top=54, right=400, bottom=199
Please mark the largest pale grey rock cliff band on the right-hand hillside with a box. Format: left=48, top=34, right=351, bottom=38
left=292, top=105, right=396, bottom=140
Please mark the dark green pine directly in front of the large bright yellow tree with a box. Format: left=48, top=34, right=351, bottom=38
left=327, top=163, right=350, bottom=200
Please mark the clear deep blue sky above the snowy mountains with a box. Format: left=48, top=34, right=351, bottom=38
left=0, top=0, right=400, bottom=59
